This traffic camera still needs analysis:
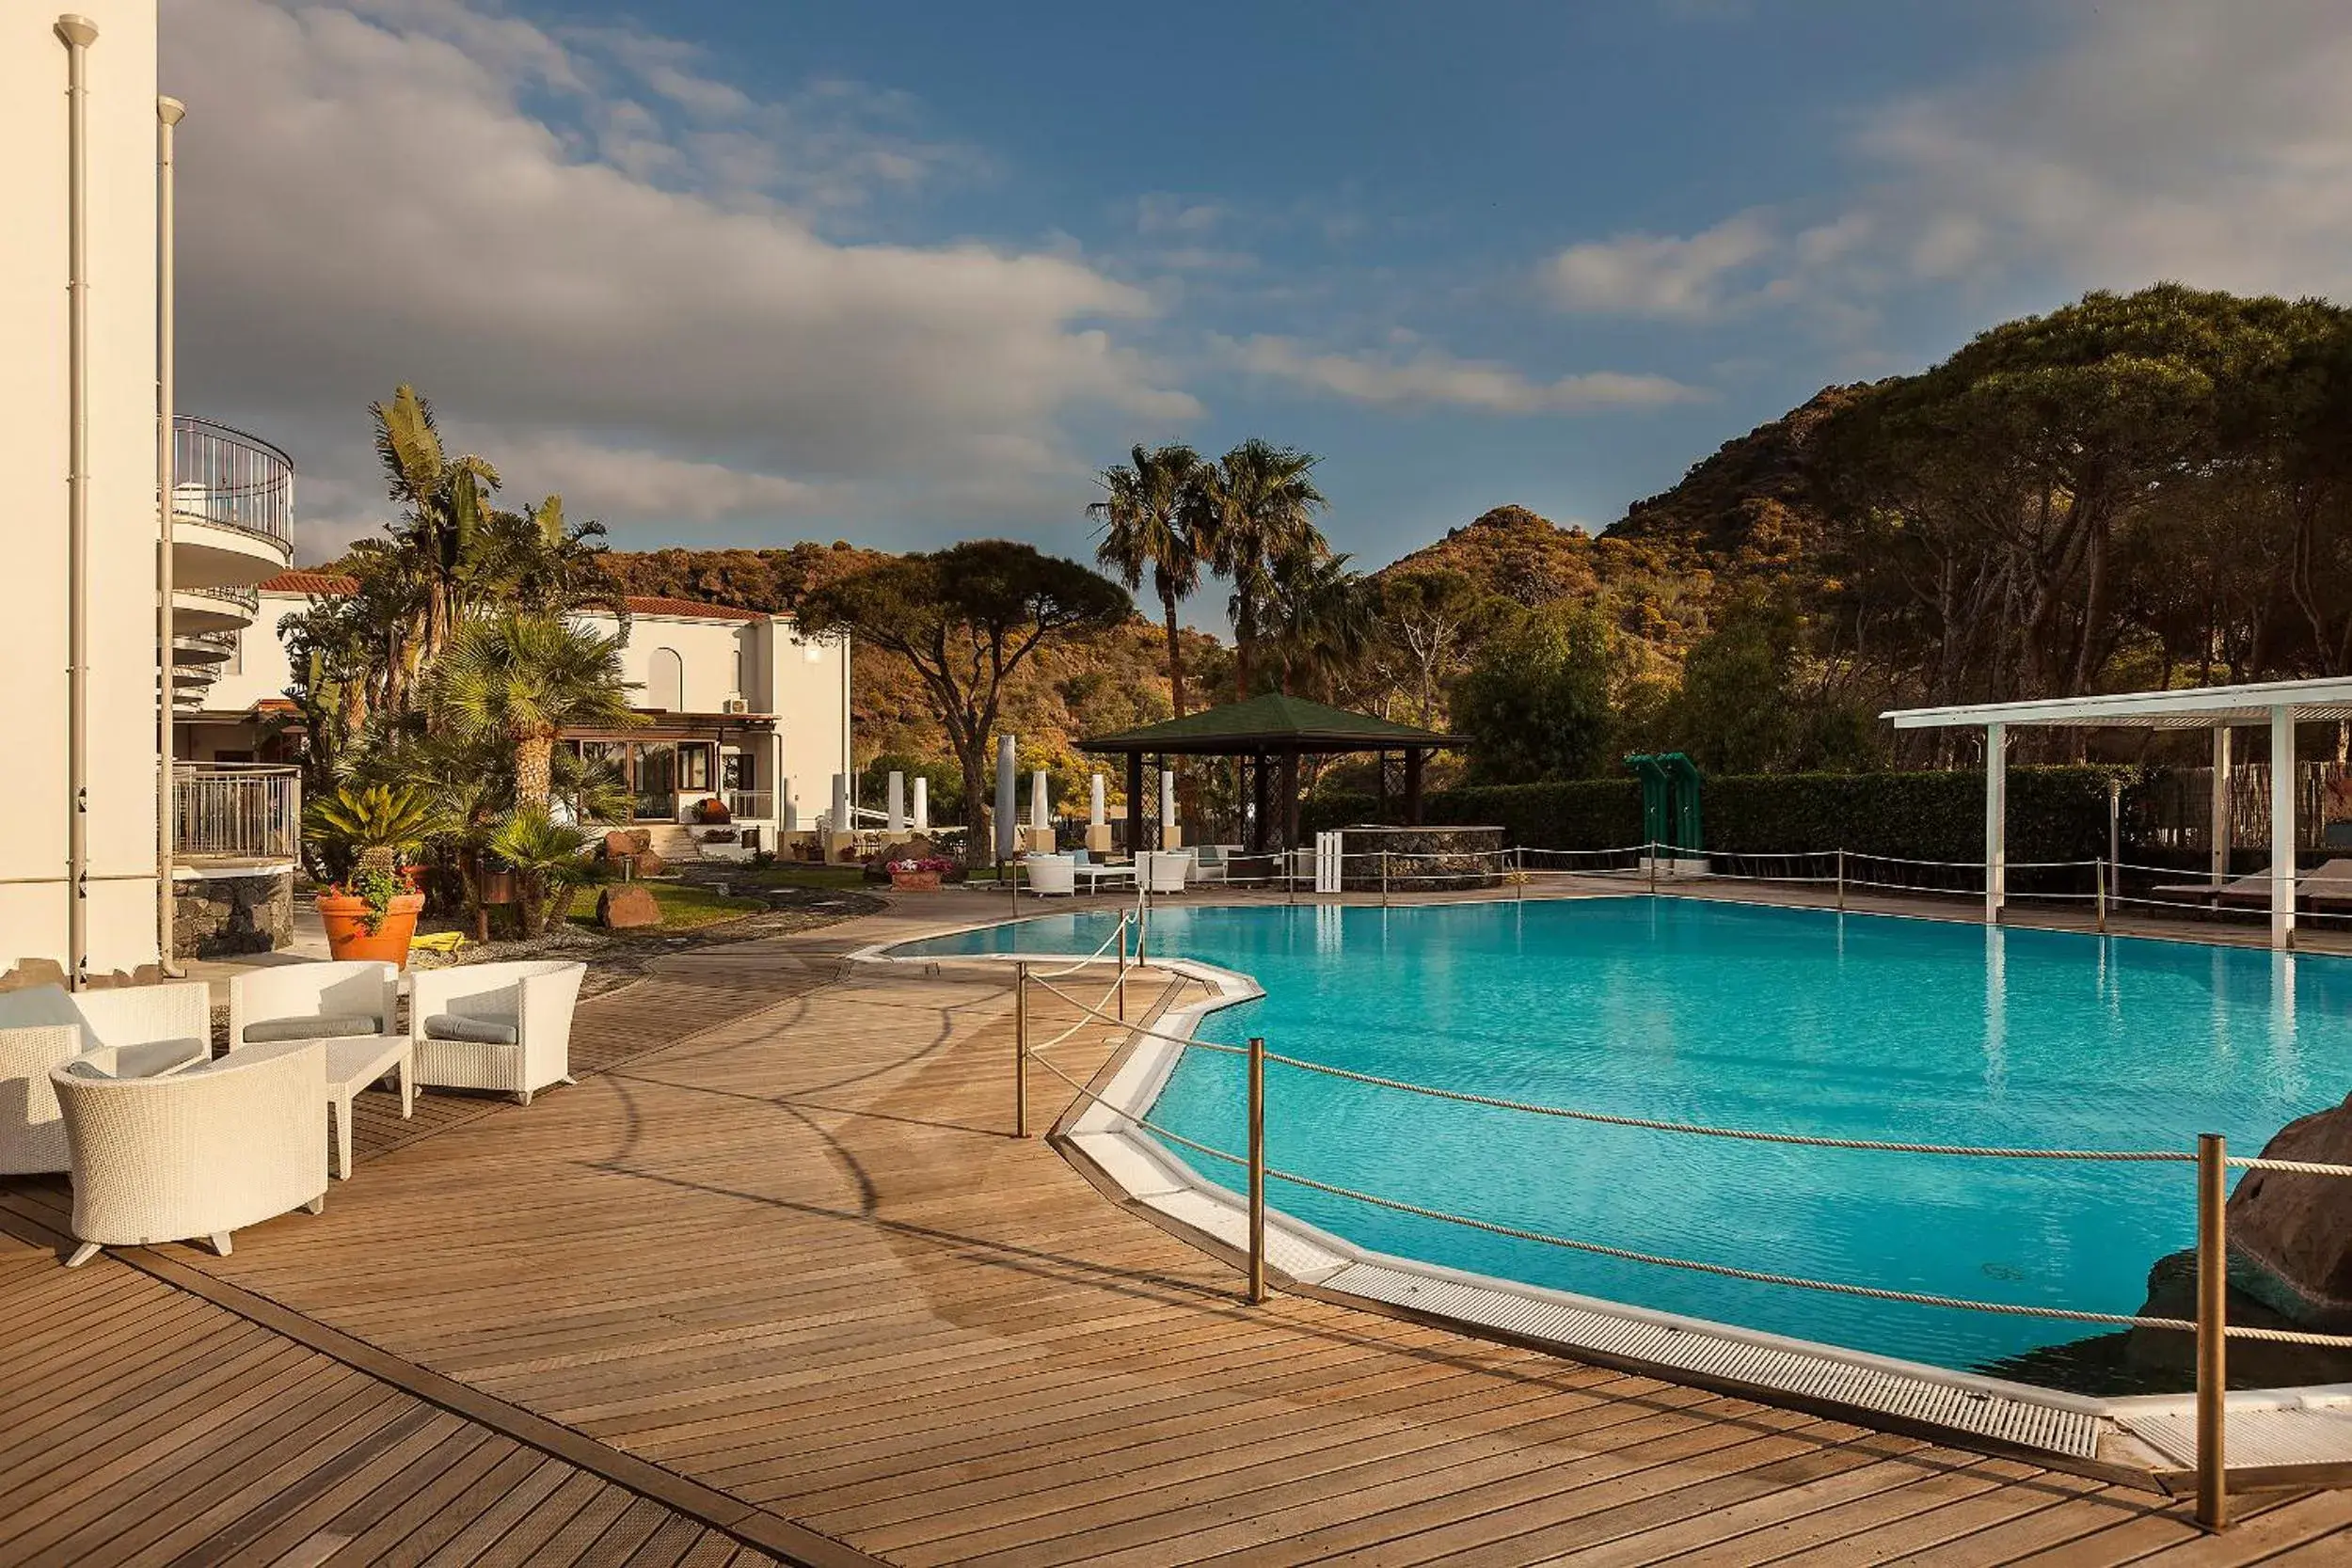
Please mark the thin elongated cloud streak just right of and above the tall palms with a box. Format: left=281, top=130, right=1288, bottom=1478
left=1214, top=336, right=1706, bottom=414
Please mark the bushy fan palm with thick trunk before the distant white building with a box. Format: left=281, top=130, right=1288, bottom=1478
left=431, top=613, right=643, bottom=811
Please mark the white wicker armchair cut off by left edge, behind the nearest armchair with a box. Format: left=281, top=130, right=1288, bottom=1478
left=0, top=983, right=212, bottom=1176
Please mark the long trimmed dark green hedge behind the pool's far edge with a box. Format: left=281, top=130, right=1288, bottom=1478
left=1298, top=767, right=2129, bottom=861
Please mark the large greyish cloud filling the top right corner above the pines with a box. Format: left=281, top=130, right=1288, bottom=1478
left=1856, top=0, right=2352, bottom=296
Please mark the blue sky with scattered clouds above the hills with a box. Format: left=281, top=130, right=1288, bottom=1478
left=163, top=0, right=2352, bottom=623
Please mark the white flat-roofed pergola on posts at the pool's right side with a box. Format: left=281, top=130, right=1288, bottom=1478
left=1880, top=677, right=2352, bottom=947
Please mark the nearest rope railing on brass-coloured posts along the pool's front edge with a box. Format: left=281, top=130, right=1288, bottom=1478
left=1014, top=930, right=2352, bottom=1530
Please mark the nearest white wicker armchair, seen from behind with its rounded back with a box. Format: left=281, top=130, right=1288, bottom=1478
left=50, top=1043, right=327, bottom=1267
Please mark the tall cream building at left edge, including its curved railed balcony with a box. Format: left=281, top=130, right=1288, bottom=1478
left=0, top=0, right=292, bottom=985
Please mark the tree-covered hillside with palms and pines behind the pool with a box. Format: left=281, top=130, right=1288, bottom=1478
left=605, top=284, right=2352, bottom=778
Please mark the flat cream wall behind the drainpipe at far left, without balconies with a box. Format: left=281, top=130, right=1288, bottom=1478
left=0, top=0, right=160, bottom=974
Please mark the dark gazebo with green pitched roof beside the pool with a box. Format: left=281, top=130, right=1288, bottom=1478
left=1077, top=691, right=1458, bottom=851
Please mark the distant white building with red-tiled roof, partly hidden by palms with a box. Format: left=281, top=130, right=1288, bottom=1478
left=179, top=571, right=850, bottom=853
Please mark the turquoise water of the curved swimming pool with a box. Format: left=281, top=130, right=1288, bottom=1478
left=897, top=898, right=2352, bottom=1369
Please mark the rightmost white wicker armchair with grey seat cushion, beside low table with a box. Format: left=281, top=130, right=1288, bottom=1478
left=409, top=961, right=588, bottom=1105
